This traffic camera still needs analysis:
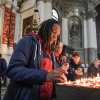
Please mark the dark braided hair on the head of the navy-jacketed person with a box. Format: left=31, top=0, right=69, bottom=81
left=38, top=19, right=60, bottom=43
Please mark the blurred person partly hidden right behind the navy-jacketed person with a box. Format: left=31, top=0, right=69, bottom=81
left=53, top=42, right=69, bottom=81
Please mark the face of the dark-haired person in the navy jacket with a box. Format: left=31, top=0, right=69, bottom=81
left=48, top=24, right=61, bottom=45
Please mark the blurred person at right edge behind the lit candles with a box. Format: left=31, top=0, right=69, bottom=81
left=87, top=59, right=100, bottom=77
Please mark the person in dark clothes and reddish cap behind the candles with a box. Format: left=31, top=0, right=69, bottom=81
left=68, top=51, right=84, bottom=81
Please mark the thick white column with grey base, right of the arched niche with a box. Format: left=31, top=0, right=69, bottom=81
left=87, top=18, right=97, bottom=61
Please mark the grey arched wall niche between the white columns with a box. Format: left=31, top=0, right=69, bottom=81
left=68, top=16, right=82, bottom=49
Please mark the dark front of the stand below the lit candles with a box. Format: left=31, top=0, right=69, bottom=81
left=56, top=84, right=100, bottom=100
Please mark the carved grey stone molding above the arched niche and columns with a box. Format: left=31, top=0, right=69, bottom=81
left=52, top=0, right=100, bottom=19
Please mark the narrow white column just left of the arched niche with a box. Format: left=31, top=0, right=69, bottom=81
left=62, top=18, right=68, bottom=45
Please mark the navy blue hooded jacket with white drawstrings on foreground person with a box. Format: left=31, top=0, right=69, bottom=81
left=4, top=36, right=47, bottom=100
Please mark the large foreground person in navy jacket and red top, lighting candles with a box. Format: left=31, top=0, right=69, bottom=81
left=4, top=19, right=64, bottom=100
